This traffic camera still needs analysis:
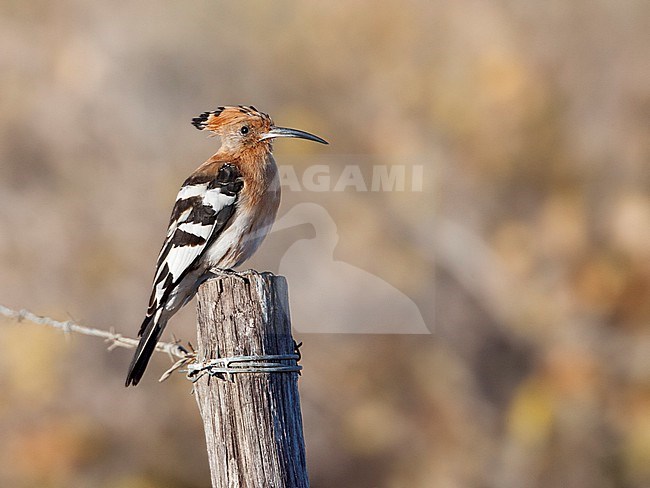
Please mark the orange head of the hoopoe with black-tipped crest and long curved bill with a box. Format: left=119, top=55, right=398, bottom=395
left=192, top=105, right=327, bottom=151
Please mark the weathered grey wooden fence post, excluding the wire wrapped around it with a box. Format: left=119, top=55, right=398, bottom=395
left=195, top=272, right=309, bottom=488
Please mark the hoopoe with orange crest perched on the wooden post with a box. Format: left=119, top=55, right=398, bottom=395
left=126, top=105, right=327, bottom=386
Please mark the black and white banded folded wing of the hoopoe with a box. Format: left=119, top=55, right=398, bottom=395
left=143, top=163, right=244, bottom=327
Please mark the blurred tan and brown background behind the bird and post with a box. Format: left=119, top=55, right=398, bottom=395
left=0, top=0, right=650, bottom=488
